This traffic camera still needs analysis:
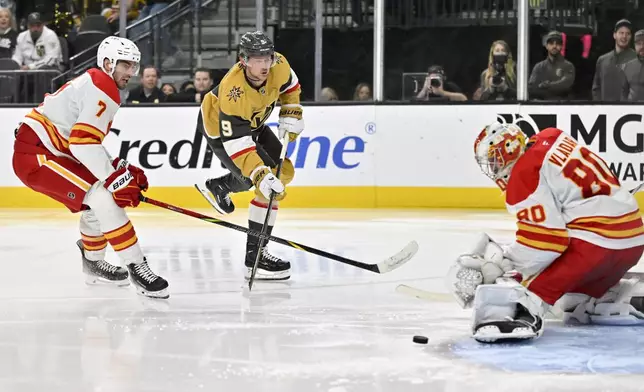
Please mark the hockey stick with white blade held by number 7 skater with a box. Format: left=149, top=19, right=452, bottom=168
left=141, top=196, right=418, bottom=274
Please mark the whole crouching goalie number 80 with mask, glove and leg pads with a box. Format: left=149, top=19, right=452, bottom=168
left=449, top=123, right=644, bottom=342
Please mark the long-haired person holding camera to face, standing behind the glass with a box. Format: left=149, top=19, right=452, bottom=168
left=479, top=41, right=517, bottom=101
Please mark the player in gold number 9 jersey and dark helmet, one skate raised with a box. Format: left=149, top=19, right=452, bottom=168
left=198, top=31, right=304, bottom=280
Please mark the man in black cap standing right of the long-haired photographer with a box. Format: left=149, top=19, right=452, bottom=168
left=528, top=31, right=575, bottom=100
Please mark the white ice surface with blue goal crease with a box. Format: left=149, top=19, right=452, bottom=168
left=0, top=209, right=644, bottom=392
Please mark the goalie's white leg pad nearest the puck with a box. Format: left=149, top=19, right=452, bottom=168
left=472, top=279, right=546, bottom=343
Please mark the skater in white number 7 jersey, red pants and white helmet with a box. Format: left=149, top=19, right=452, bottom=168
left=13, top=37, right=168, bottom=298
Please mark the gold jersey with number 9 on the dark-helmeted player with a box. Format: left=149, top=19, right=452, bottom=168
left=201, top=52, right=301, bottom=177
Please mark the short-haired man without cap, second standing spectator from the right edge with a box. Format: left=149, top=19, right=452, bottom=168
left=593, top=19, right=637, bottom=101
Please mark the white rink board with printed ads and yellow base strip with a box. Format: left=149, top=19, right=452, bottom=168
left=0, top=105, right=644, bottom=208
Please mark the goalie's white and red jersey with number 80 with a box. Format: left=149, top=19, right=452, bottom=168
left=506, top=128, right=644, bottom=279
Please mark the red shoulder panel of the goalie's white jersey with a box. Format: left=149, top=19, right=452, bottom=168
left=505, top=128, right=562, bottom=205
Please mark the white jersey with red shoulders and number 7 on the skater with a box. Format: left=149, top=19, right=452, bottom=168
left=23, top=69, right=121, bottom=180
